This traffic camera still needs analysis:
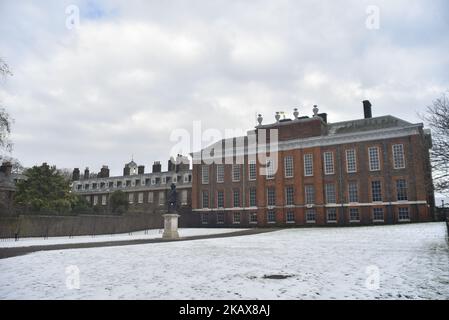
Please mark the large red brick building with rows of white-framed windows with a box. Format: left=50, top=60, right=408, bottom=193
left=192, top=101, right=434, bottom=227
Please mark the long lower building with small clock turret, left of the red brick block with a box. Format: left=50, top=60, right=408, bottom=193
left=72, top=155, right=192, bottom=212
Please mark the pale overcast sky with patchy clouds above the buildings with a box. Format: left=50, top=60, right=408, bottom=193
left=0, top=0, right=449, bottom=188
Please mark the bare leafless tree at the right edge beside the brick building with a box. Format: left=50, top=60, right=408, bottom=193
left=423, top=91, right=449, bottom=194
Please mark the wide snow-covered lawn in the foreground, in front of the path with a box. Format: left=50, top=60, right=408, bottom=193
left=0, top=223, right=449, bottom=299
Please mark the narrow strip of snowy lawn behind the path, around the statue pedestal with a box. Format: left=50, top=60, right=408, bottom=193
left=0, top=228, right=247, bottom=248
